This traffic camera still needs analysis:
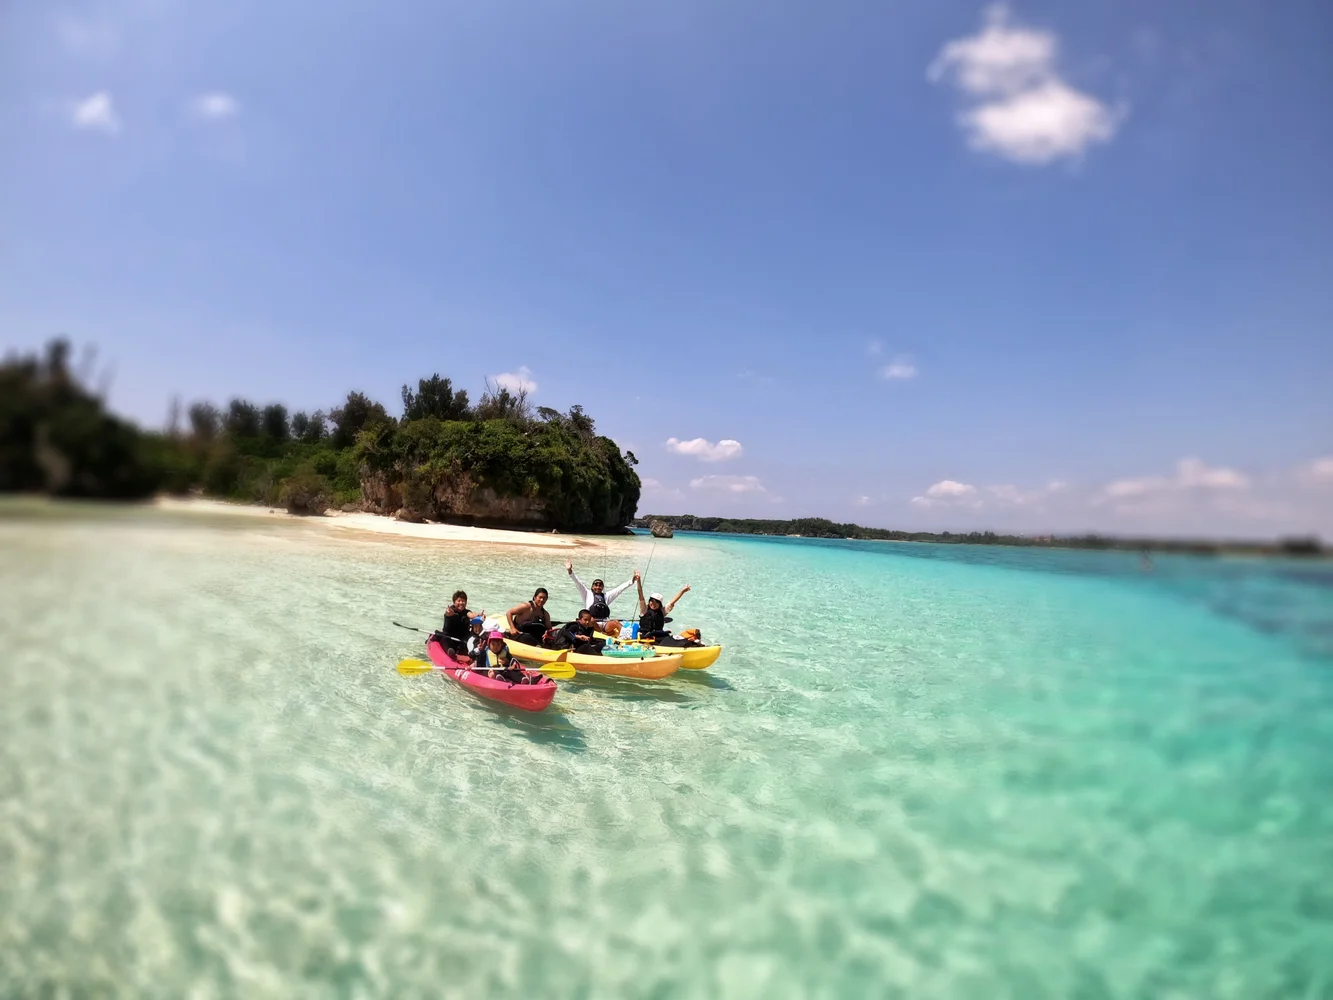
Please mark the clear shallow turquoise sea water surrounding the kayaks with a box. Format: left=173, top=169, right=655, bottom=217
left=0, top=508, right=1333, bottom=1000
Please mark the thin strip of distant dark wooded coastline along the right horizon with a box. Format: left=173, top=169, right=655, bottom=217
left=632, top=513, right=1325, bottom=556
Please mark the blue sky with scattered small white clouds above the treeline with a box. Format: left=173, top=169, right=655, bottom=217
left=0, top=0, right=1333, bottom=537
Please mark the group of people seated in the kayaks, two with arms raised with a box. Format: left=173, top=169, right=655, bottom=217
left=435, top=561, right=702, bottom=684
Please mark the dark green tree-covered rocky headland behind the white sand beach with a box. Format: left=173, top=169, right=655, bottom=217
left=0, top=341, right=640, bottom=531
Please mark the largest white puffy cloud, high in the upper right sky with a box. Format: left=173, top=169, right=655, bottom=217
left=926, top=4, right=1125, bottom=164
